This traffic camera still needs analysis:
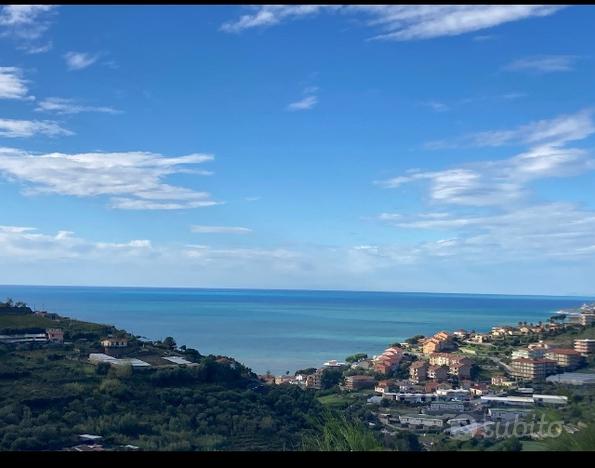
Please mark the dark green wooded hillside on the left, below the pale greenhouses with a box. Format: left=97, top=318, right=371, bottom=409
left=0, top=306, right=323, bottom=450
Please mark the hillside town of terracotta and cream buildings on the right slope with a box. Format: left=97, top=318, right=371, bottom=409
left=260, top=304, right=595, bottom=437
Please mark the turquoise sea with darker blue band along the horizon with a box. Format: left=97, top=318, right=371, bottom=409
left=0, top=286, right=593, bottom=373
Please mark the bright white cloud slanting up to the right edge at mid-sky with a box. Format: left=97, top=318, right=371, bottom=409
left=376, top=111, right=595, bottom=206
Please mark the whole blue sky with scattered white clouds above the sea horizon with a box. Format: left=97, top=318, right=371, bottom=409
left=0, top=5, right=595, bottom=295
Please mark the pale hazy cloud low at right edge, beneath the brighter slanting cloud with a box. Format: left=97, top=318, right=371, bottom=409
left=379, top=202, right=595, bottom=262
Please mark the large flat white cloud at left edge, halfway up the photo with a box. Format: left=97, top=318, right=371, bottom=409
left=0, top=148, right=218, bottom=210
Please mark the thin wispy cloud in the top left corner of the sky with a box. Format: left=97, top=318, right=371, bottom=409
left=0, top=5, right=56, bottom=54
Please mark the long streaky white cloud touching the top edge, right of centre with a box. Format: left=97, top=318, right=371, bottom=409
left=221, top=5, right=563, bottom=41
